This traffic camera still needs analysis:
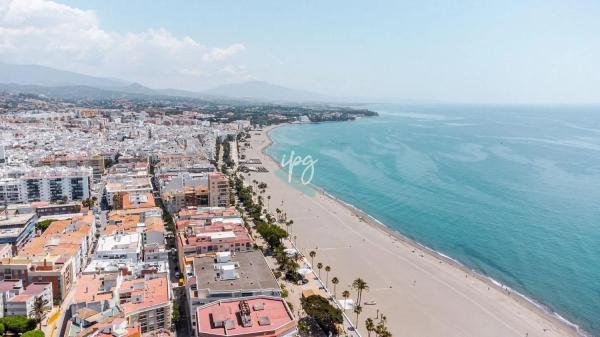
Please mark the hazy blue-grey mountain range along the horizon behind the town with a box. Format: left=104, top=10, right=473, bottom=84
left=0, top=63, right=328, bottom=102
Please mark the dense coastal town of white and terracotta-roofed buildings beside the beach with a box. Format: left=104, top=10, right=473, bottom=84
left=0, top=93, right=384, bottom=337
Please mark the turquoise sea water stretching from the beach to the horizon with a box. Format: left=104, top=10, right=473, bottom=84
left=267, top=104, right=600, bottom=336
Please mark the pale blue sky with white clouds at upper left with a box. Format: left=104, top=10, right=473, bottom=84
left=0, top=0, right=600, bottom=104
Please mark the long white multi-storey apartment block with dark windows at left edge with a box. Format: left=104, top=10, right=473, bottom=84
left=0, top=167, right=92, bottom=204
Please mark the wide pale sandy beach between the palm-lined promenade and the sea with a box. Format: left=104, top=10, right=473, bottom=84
left=242, top=127, right=578, bottom=337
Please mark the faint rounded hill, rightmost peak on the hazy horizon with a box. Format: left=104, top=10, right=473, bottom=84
left=202, top=81, right=327, bottom=102
